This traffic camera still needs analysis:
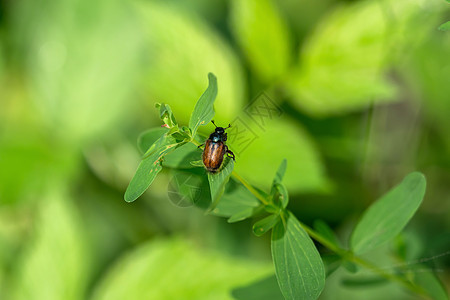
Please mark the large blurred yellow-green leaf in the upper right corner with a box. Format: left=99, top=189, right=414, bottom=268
left=287, top=0, right=444, bottom=117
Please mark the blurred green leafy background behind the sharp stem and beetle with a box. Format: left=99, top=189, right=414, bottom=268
left=0, top=0, right=450, bottom=300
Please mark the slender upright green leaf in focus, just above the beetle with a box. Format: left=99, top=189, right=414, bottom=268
left=189, top=73, right=217, bottom=136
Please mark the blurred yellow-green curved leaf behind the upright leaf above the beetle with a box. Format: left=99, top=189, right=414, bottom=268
left=135, top=1, right=245, bottom=128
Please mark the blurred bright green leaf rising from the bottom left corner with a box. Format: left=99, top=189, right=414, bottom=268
left=10, top=188, right=88, bottom=300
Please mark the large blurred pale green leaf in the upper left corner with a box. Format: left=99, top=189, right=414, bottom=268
left=11, top=0, right=141, bottom=146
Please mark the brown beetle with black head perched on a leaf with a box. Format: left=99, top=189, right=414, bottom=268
left=199, top=120, right=236, bottom=173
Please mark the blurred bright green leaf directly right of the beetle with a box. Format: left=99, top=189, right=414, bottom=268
left=234, top=117, right=329, bottom=193
